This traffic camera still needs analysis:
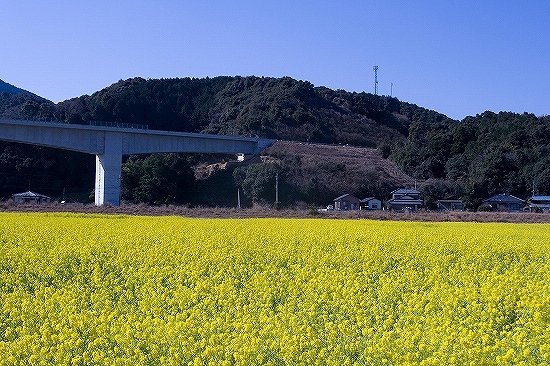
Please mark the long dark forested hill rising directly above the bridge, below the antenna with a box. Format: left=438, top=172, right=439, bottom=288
left=49, top=76, right=452, bottom=146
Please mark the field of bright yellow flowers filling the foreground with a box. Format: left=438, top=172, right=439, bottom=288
left=0, top=213, right=550, bottom=365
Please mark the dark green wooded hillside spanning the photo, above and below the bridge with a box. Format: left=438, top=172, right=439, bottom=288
left=0, top=76, right=550, bottom=208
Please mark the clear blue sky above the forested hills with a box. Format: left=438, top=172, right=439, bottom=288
left=0, top=0, right=550, bottom=119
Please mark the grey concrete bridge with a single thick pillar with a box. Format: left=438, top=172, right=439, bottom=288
left=0, top=119, right=274, bottom=206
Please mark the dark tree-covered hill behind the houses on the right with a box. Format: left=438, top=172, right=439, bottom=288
left=391, top=111, right=550, bottom=208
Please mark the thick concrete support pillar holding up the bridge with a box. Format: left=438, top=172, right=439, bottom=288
left=95, top=132, right=122, bottom=206
